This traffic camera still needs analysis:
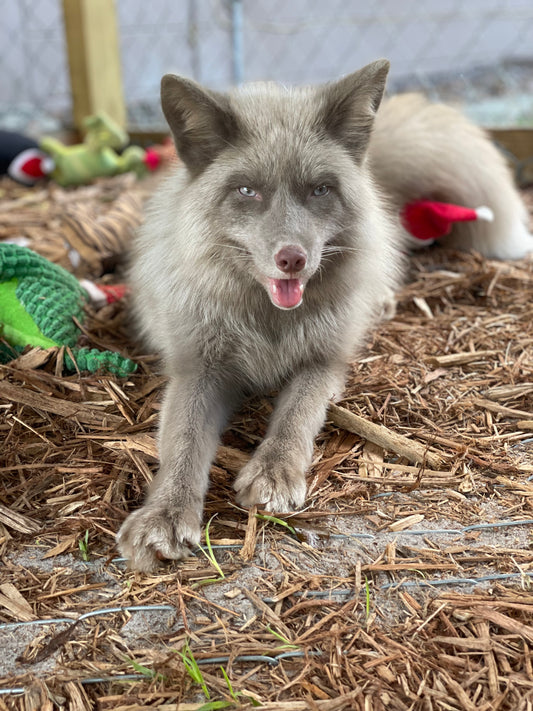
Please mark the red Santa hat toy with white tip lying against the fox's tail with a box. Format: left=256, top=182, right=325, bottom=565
left=400, top=200, right=494, bottom=246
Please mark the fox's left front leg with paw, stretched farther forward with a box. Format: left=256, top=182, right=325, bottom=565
left=117, top=373, right=233, bottom=572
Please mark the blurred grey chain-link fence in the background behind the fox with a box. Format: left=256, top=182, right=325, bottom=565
left=0, top=0, right=533, bottom=130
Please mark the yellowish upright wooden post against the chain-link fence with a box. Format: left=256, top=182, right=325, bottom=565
left=63, top=0, right=126, bottom=132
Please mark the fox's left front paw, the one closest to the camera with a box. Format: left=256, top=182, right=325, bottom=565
left=117, top=504, right=200, bottom=573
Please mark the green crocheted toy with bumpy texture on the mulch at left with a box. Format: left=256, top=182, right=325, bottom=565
left=0, top=244, right=137, bottom=377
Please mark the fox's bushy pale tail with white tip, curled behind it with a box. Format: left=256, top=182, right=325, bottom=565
left=369, top=94, right=533, bottom=259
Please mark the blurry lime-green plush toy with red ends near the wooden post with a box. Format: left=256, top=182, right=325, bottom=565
left=0, top=113, right=161, bottom=186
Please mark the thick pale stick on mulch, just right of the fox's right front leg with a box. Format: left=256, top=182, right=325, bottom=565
left=328, top=404, right=444, bottom=469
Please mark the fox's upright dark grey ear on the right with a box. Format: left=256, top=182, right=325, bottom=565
left=321, top=59, right=390, bottom=161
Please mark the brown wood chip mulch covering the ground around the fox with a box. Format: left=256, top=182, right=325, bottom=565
left=0, top=178, right=533, bottom=711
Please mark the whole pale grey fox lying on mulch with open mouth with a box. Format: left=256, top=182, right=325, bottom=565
left=117, top=59, right=533, bottom=572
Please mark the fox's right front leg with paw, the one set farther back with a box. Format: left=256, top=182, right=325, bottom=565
left=234, top=366, right=344, bottom=511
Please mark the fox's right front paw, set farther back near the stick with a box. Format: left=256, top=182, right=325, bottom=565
left=233, top=449, right=306, bottom=512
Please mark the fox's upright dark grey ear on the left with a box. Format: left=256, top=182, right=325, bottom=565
left=161, top=74, right=237, bottom=175
